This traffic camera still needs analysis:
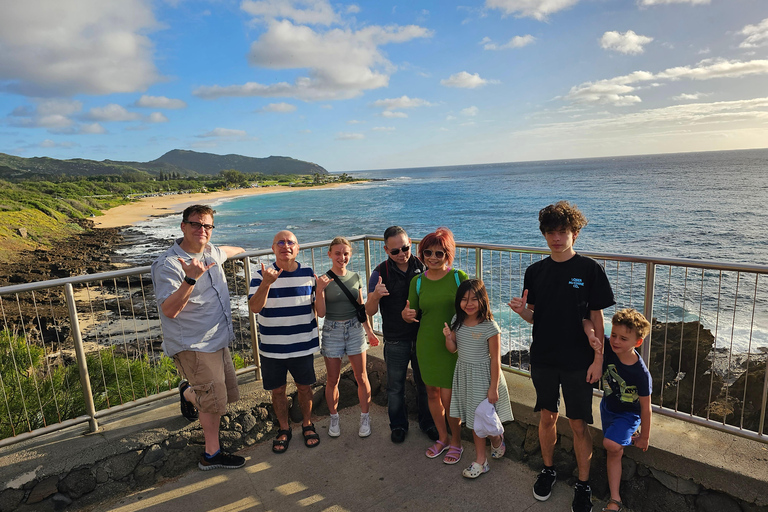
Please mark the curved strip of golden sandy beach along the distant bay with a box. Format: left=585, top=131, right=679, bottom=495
left=93, top=183, right=348, bottom=228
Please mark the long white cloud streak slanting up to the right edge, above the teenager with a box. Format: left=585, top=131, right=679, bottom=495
left=565, top=59, right=768, bottom=106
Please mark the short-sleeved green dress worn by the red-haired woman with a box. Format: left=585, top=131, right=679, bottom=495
left=408, top=270, right=467, bottom=389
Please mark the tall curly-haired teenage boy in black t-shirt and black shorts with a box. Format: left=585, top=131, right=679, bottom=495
left=509, top=201, right=615, bottom=512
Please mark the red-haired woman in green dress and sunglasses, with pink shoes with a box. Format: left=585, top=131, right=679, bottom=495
left=402, top=228, right=467, bottom=464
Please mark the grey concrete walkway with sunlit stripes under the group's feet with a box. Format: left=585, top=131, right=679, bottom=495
left=88, top=405, right=572, bottom=512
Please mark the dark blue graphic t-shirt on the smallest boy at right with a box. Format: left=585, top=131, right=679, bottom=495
left=602, top=336, right=653, bottom=414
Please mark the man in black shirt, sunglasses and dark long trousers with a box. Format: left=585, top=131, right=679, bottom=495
left=365, top=226, right=437, bottom=443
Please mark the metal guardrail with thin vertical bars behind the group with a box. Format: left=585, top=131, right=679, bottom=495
left=0, top=235, right=768, bottom=446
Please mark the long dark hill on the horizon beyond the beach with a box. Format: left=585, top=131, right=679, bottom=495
left=0, top=149, right=328, bottom=179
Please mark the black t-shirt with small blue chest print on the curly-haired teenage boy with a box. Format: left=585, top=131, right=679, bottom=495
left=524, top=254, right=615, bottom=370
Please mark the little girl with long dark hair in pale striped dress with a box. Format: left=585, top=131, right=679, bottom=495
left=443, top=279, right=513, bottom=478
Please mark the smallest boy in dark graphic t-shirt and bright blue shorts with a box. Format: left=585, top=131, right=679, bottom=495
left=584, top=309, right=653, bottom=512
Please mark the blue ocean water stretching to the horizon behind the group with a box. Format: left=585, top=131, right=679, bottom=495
left=122, top=149, right=768, bottom=351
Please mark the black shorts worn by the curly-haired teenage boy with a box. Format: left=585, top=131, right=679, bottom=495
left=531, top=364, right=593, bottom=425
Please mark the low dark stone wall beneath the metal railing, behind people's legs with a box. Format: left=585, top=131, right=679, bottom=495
left=0, top=357, right=768, bottom=512
